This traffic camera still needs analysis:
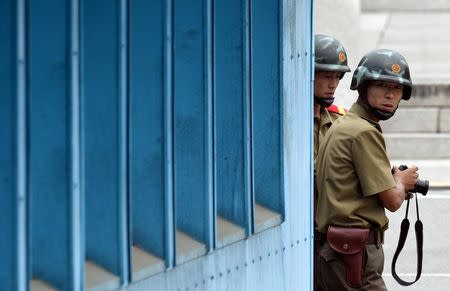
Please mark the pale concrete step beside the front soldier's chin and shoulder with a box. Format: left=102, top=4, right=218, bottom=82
left=380, top=104, right=450, bottom=133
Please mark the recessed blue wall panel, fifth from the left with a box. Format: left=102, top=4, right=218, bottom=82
left=174, top=0, right=212, bottom=249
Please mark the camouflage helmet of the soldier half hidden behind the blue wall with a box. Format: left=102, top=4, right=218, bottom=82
left=314, top=34, right=350, bottom=78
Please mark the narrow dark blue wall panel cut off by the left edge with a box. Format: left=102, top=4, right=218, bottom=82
left=0, top=1, right=17, bottom=290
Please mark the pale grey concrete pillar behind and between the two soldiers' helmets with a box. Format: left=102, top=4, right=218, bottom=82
left=315, top=0, right=362, bottom=108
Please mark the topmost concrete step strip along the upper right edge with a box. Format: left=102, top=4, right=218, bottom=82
left=361, top=0, right=450, bottom=11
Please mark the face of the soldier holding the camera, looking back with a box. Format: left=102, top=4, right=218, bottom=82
left=367, top=81, right=403, bottom=112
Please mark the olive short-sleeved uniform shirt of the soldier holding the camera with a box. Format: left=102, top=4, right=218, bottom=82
left=316, top=103, right=395, bottom=233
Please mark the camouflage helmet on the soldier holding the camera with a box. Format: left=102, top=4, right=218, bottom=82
left=350, top=49, right=412, bottom=100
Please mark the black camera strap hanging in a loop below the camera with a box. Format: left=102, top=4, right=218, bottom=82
left=391, top=194, right=423, bottom=286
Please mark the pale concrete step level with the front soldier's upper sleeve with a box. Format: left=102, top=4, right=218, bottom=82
left=384, top=133, right=450, bottom=160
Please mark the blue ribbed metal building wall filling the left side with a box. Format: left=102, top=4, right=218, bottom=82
left=0, top=0, right=313, bottom=291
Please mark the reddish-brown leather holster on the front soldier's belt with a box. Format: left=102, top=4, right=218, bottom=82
left=327, top=225, right=369, bottom=288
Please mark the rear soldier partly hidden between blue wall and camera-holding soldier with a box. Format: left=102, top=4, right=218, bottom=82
left=314, top=34, right=350, bottom=290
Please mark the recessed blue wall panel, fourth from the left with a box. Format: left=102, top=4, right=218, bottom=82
left=130, top=0, right=165, bottom=258
